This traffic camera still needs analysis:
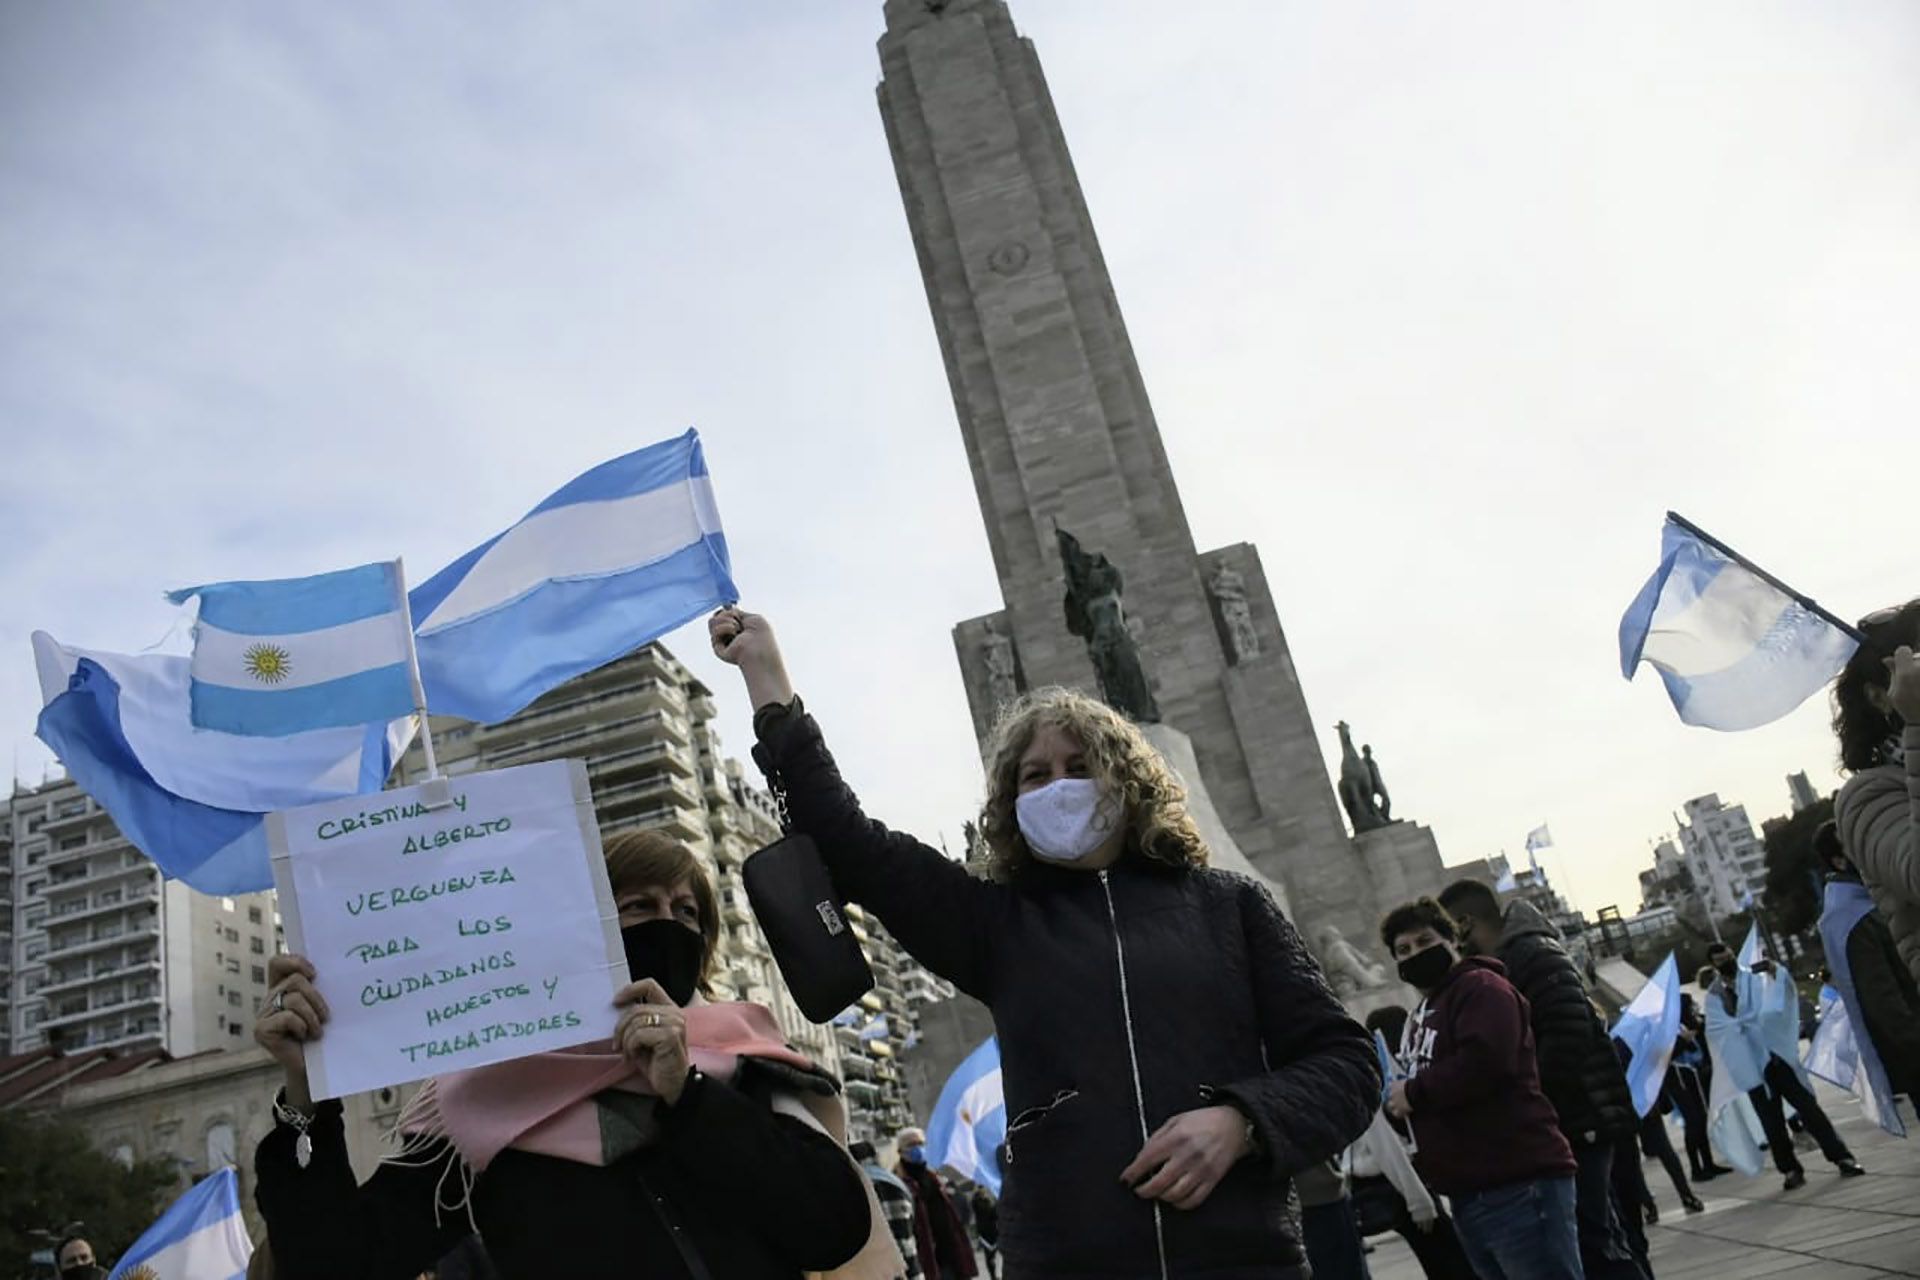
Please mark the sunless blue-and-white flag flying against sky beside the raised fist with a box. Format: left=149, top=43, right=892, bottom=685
left=411, top=430, right=739, bottom=723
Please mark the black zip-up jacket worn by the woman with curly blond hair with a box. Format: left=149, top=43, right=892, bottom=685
left=755, top=708, right=1380, bottom=1280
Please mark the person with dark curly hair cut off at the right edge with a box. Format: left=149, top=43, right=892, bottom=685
left=1834, top=601, right=1920, bottom=983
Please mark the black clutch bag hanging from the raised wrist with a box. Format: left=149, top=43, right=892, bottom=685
left=741, top=833, right=874, bottom=1023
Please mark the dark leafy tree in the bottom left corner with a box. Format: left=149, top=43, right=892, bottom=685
left=0, top=1111, right=179, bottom=1276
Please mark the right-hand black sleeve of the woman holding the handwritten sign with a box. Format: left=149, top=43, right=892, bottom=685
left=660, top=1077, right=874, bottom=1270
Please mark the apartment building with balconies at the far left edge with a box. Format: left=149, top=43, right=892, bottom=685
left=0, top=779, right=278, bottom=1057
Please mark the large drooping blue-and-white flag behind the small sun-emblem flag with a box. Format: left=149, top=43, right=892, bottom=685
left=33, top=631, right=415, bottom=894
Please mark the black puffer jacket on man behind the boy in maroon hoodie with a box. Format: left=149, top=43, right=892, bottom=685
left=1498, top=898, right=1640, bottom=1146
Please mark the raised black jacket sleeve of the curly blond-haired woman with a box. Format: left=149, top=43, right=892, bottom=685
left=753, top=706, right=1000, bottom=1002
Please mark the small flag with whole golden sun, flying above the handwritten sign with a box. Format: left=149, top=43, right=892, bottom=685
left=167, top=560, right=415, bottom=737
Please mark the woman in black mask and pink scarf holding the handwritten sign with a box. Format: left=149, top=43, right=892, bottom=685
left=253, top=831, right=899, bottom=1280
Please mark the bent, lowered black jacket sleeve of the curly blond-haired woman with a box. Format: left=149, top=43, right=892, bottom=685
left=1215, top=881, right=1380, bottom=1176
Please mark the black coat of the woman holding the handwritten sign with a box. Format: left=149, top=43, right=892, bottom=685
left=253, top=1077, right=872, bottom=1280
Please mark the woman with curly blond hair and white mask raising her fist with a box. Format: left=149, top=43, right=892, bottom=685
left=708, top=608, right=1380, bottom=1280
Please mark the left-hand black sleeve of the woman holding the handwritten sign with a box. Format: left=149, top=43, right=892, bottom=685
left=253, top=1102, right=472, bottom=1280
